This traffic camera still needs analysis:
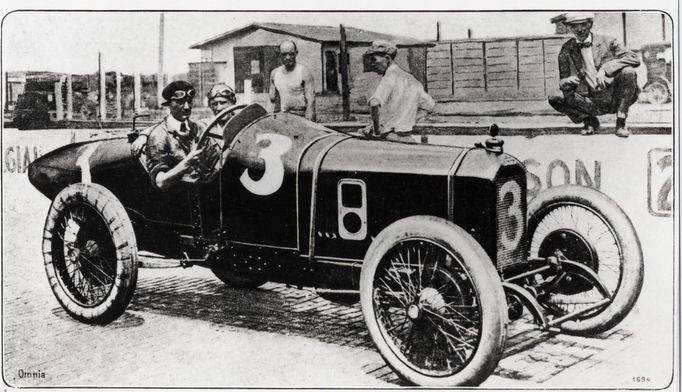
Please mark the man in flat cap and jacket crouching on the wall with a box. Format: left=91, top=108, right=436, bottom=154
left=549, top=12, right=639, bottom=137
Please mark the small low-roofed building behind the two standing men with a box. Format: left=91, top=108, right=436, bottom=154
left=188, top=23, right=433, bottom=111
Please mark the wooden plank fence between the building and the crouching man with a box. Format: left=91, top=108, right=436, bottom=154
left=426, top=35, right=568, bottom=101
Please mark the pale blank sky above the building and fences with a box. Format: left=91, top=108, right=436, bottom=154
left=1, top=11, right=558, bottom=74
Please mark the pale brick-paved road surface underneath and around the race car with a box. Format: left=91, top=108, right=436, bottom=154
left=2, top=172, right=672, bottom=389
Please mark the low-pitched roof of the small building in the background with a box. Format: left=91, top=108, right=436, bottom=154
left=189, top=23, right=433, bottom=49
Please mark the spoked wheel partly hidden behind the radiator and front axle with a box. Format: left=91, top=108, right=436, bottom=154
left=528, top=186, right=644, bottom=334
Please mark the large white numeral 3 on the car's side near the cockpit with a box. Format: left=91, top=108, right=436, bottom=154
left=239, top=133, right=292, bottom=196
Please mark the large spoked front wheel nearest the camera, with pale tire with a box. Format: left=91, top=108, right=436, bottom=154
left=360, top=216, right=506, bottom=386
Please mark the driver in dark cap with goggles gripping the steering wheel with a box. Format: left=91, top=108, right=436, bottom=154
left=143, top=80, right=206, bottom=190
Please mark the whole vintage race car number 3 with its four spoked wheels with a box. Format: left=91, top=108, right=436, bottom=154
left=29, top=104, right=643, bottom=386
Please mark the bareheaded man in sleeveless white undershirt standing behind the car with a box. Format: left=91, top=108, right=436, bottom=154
left=270, top=41, right=315, bottom=121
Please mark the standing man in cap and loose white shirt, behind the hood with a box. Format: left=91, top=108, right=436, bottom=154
left=361, top=40, right=435, bottom=142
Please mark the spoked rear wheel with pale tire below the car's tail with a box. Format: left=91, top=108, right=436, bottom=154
left=43, top=184, right=137, bottom=323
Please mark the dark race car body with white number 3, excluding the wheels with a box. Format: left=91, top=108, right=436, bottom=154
left=29, top=105, right=526, bottom=288
